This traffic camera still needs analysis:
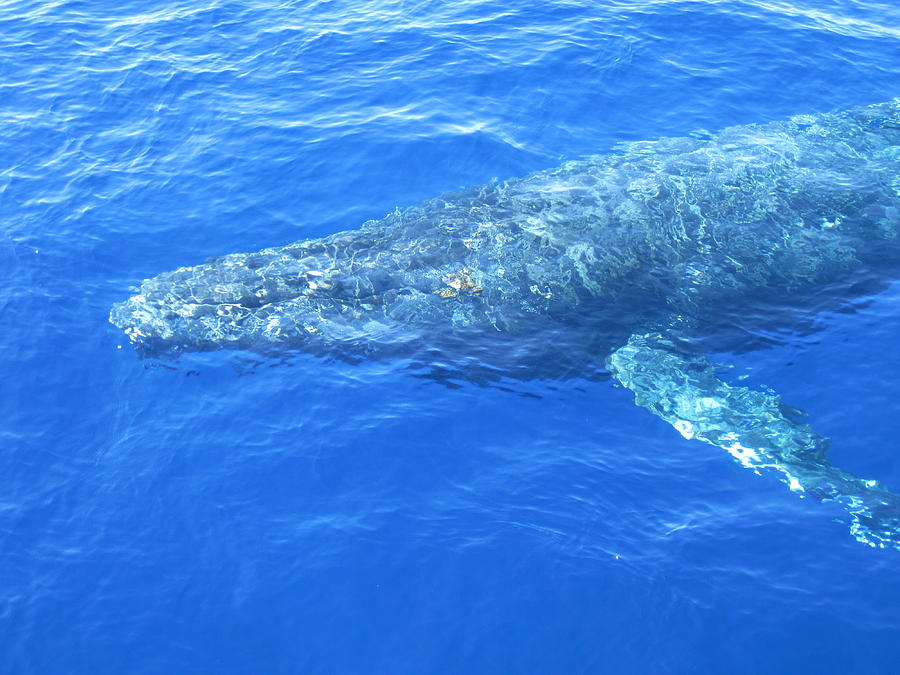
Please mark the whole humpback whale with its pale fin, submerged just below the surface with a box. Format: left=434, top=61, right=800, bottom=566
left=110, top=99, right=900, bottom=548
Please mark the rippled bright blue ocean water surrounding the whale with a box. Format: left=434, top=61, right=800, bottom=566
left=0, top=0, right=900, bottom=673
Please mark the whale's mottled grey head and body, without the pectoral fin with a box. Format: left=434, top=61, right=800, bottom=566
left=110, top=100, right=900, bottom=362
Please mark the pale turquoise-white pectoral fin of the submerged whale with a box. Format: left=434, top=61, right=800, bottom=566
left=607, top=334, right=900, bottom=548
